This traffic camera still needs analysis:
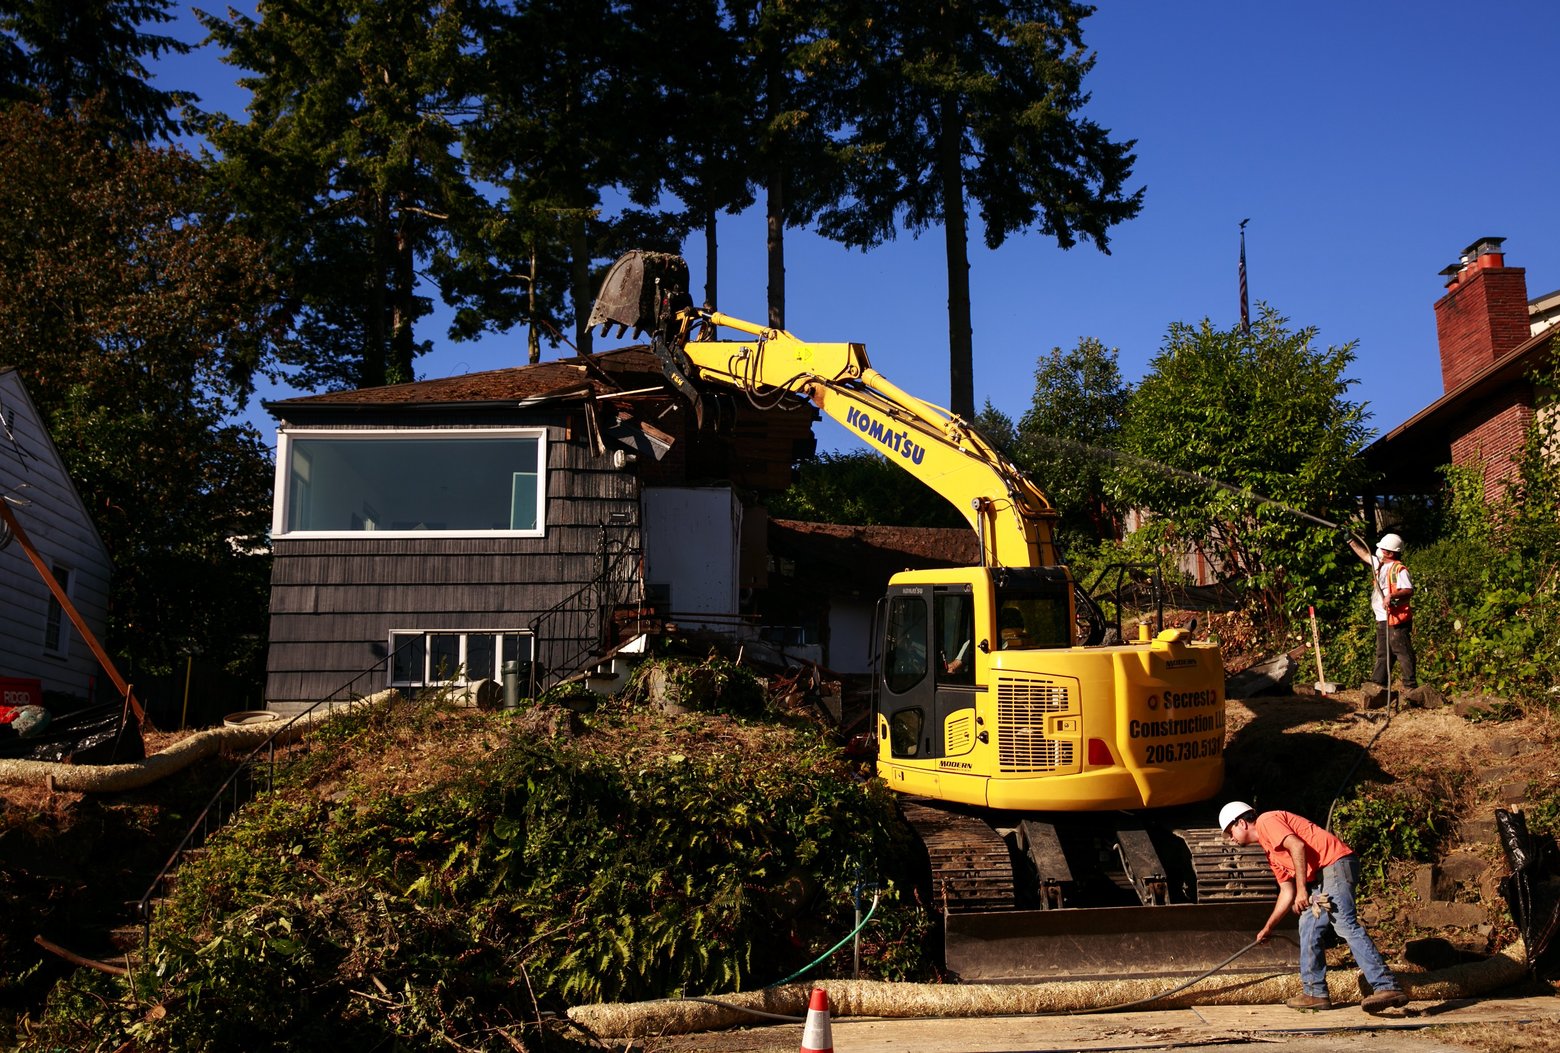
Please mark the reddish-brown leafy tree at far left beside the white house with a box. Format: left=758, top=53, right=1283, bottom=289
left=0, top=103, right=276, bottom=672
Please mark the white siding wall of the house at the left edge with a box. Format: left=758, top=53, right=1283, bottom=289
left=0, top=370, right=111, bottom=697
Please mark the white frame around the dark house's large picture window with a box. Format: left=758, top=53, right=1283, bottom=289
left=271, top=427, right=548, bottom=540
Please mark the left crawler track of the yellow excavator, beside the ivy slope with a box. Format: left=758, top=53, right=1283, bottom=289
left=900, top=800, right=1014, bottom=914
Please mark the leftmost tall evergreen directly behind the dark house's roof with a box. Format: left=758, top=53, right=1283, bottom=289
left=201, top=0, right=484, bottom=388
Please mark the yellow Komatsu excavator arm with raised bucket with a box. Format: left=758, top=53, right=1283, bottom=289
left=590, top=251, right=1061, bottom=568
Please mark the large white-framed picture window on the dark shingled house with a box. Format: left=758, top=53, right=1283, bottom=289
left=275, top=429, right=546, bottom=537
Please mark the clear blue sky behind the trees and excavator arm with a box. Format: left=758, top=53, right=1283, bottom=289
left=159, top=0, right=1560, bottom=458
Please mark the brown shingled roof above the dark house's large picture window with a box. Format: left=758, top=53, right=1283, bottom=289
left=264, top=348, right=666, bottom=417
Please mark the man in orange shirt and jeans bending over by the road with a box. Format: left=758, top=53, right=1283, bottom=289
left=1218, top=800, right=1409, bottom=1012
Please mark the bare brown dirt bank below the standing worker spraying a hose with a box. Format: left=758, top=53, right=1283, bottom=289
left=1226, top=691, right=1560, bottom=967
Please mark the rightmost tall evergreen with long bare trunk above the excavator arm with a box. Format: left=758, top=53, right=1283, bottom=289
left=819, top=0, right=1143, bottom=420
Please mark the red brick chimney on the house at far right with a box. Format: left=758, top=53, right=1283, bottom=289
left=1435, top=237, right=1530, bottom=392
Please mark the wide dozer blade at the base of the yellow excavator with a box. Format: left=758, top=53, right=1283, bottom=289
left=944, top=902, right=1299, bottom=983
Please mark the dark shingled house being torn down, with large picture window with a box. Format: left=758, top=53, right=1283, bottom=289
left=265, top=348, right=817, bottom=708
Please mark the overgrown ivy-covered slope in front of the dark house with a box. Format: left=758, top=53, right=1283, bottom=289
left=22, top=660, right=925, bottom=1050
